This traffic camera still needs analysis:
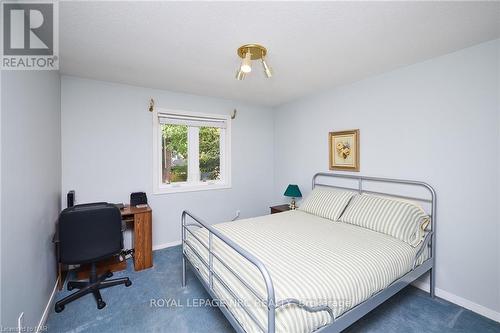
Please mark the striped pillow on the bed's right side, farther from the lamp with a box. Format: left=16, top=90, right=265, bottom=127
left=340, top=194, right=430, bottom=246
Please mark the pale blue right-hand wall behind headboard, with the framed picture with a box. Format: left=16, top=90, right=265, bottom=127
left=274, top=40, right=500, bottom=320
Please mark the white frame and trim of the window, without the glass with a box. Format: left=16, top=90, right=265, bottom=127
left=153, top=107, right=231, bottom=194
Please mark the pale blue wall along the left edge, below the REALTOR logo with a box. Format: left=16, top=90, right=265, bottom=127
left=0, top=71, right=61, bottom=329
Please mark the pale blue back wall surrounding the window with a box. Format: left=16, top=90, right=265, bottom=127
left=62, top=76, right=273, bottom=246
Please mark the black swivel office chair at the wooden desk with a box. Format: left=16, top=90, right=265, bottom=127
left=55, top=202, right=132, bottom=312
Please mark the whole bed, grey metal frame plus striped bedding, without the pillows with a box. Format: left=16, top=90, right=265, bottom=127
left=182, top=173, right=436, bottom=332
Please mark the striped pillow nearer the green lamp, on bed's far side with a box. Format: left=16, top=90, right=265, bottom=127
left=299, top=187, right=356, bottom=221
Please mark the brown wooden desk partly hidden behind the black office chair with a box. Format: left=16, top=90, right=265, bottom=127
left=57, top=202, right=153, bottom=290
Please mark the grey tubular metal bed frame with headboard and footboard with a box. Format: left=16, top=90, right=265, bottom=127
left=181, top=172, right=436, bottom=333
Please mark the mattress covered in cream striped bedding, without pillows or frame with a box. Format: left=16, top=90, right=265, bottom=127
left=183, top=210, right=428, bottom=333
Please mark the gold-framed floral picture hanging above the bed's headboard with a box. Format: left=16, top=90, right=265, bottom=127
left=328, top=129, right=359, bottom=171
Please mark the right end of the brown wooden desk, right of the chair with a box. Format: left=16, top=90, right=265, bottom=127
left=121, top=206, right=153, bottom=271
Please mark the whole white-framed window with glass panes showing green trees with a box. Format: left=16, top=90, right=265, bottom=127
left=153, top=109, right=231, bottom=193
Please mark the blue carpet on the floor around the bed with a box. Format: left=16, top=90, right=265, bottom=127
left=47, top=246, right=500, bottom=333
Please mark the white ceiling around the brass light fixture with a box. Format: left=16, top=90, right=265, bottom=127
left=60, top=1, right=500, bottom=106
